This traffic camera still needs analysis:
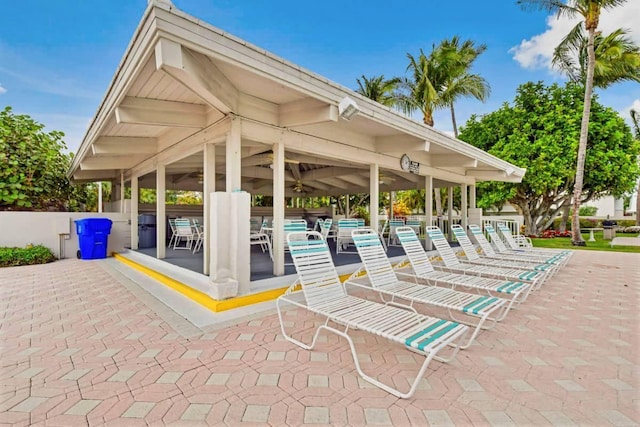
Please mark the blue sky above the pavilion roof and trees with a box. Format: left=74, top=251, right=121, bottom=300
left=0, top=0, right=640, bottom=151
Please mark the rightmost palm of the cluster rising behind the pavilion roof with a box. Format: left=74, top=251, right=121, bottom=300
left=437, top=36, right=491, bottom=138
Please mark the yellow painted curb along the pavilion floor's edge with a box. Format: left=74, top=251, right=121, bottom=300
left=113, top=252, right=350, bottom=313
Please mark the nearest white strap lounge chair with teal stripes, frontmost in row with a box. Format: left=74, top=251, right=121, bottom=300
left=276, top=232, right=469, bottom=399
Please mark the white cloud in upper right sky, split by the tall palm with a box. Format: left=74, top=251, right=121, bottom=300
left=509, top=0, right=640, bottom=69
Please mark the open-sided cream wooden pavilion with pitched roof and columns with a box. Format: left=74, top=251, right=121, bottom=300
left=69, top=0, right=525, bottom=300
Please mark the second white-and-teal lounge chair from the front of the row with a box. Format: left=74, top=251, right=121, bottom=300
left=345, top=229, right=511, bottom=349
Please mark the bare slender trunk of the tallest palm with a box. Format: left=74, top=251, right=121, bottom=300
left=571, top=27, right=596, bottom=246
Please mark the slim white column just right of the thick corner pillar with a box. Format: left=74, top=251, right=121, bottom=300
left=272, top=142, right=285, bottom=276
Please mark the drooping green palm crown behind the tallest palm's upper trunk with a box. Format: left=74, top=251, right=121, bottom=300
left=552, top=25, right=640, bottom=88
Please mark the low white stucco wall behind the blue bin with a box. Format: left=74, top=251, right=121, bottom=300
left=0, top=212, right=131, bottom=258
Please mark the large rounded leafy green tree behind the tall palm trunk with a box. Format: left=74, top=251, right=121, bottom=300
left=460, top=82, right=640, bottom=235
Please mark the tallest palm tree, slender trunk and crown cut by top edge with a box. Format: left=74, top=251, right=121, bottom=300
left=517, top=0, right=626, bottom=246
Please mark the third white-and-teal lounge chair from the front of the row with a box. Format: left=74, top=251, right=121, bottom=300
left=397, top=227, right=536, bottom=310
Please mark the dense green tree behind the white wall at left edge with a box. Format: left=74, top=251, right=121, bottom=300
left=0, top=107, right=73, bottom=210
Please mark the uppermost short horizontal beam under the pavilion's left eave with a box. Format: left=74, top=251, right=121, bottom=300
left=116, top=96, right=207, bottom=128
